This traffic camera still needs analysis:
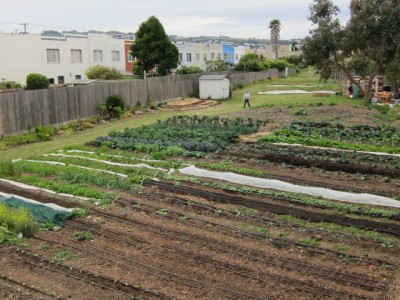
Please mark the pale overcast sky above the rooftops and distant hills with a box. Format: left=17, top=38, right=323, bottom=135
left=0, top=0, right=350, bottom=39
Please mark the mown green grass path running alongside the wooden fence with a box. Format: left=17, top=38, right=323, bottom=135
left=1, top=70, right=363, bottom=159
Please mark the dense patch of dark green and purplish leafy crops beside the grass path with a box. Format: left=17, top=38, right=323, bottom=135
left=86, top=116, right=262, bottom=155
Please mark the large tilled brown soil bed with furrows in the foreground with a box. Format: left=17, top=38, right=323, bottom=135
left=0, top=178, right=399, bottom=299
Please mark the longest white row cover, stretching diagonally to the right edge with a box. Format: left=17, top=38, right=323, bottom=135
left=179, top=165, right=400, bottom=208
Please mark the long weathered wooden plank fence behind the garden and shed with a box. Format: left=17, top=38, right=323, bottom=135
left=0, top=69, right=279, bottom=136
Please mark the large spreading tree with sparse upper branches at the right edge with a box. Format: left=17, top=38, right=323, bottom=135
left=304, top=0, right=400, bottom=100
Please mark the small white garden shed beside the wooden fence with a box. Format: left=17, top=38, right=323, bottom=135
left=199, top=75, right=230, bottom=99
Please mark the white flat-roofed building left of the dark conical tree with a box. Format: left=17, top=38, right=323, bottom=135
left=0, top=31, right=125, bottom=85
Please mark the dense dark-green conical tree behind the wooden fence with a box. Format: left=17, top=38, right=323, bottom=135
left=131, top=16, right=179, bottom=75
